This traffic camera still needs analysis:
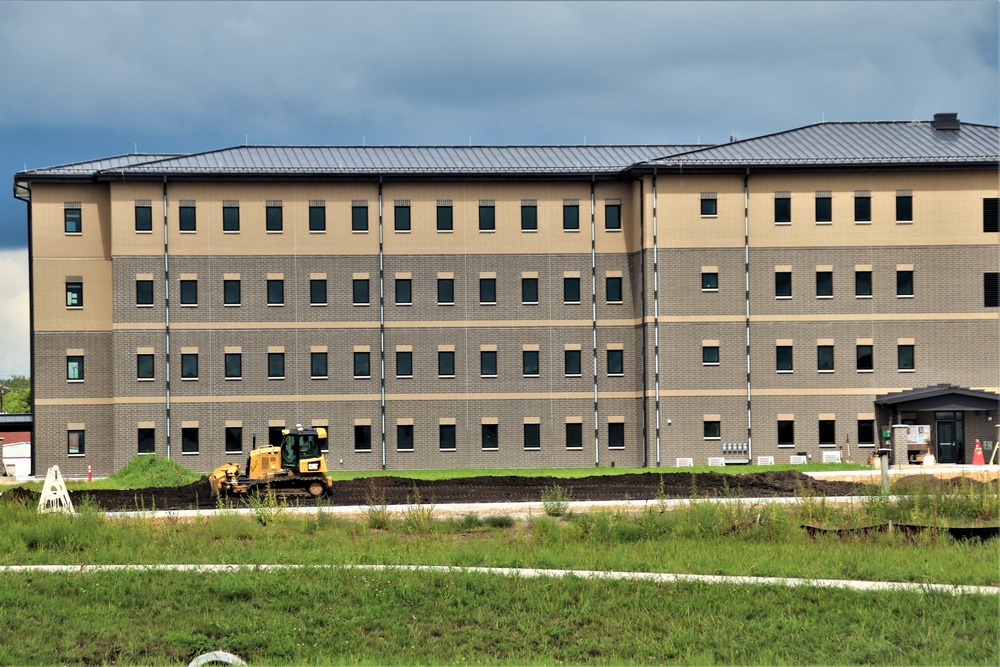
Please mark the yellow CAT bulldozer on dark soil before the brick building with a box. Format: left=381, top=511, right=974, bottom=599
left=209, top=424, right=333, bottom=497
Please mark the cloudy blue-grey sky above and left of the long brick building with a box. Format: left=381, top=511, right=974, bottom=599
left=0, top=0, right=1000, bottom=376
